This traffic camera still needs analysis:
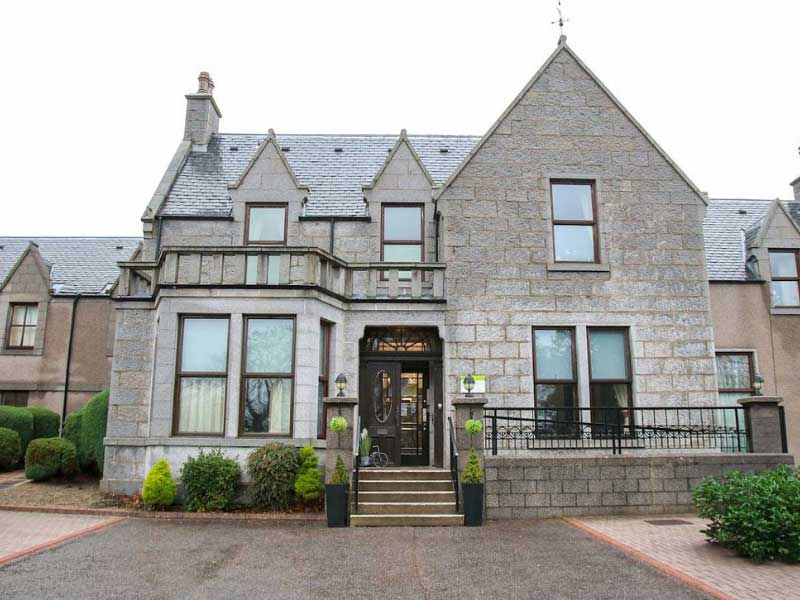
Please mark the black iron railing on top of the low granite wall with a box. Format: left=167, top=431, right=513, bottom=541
left=484, top=406, right=750, bottom=454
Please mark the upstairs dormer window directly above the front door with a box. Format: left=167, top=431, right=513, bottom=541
left=381, top=204, right=424, bottom=279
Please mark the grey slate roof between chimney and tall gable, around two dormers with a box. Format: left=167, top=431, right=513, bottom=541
left=159, top=133, right=480, bottom=217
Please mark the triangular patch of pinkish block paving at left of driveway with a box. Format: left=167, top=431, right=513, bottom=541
left=0, top=511, right=120, bottom=565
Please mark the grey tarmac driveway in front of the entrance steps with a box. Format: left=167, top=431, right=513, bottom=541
left=0, top=519, right=705, bottom=600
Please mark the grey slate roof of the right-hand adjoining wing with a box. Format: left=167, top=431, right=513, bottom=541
left=703, top=199, right=800, bottom=281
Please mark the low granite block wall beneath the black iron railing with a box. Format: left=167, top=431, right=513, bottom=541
left=485, top=454, right=794, bottom=519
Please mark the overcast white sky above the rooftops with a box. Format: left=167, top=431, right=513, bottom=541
left=0, top=0, right=800, bottom=235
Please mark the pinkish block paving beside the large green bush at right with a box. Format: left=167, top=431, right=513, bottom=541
left=574, top=515, right=800, bottom=600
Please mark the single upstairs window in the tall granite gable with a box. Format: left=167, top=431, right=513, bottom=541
left=550, top=181, right=599, bottom=263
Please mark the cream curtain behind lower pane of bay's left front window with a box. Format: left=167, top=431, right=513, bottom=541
left=179, top=377, right=226, bottom=433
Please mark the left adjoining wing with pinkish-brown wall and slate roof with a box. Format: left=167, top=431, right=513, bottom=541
left=0, top=237, right=140, bottom=415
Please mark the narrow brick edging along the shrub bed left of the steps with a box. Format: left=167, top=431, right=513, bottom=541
left=0, top=504, right=325, bottom=521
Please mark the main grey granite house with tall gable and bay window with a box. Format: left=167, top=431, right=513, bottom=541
left=98, top=38, right=732, bottom=492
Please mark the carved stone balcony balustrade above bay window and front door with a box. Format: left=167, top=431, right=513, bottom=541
left=115, top=246, right=445, bottom=302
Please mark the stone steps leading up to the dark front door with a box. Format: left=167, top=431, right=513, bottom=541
left=350, top=467, right=464, bottom=527
